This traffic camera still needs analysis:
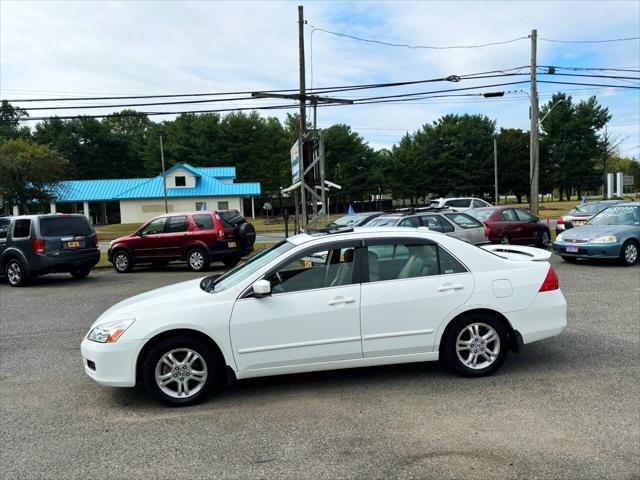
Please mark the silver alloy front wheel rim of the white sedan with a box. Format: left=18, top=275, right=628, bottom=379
left=155, top=348, right=207, bottom=398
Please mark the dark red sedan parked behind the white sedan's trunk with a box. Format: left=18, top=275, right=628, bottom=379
left=465, top=207, right=551, bottom=248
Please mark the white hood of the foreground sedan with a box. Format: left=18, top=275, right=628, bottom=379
left=91, top=278, right=205, bottom=328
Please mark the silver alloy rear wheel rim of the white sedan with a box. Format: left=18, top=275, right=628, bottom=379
left=456, top=323, right=500, bottom=370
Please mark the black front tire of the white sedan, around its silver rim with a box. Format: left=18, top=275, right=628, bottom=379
left=142, top=335, right=223, bottom=407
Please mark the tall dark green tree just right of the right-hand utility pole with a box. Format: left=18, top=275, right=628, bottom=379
left=540, top=93, right=611, bottom=200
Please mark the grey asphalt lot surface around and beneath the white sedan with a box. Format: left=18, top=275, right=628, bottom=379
left=0, top=257, right=640, bottom=479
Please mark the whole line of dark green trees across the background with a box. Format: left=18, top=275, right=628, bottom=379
left=0, top=93, right=640, bottom=213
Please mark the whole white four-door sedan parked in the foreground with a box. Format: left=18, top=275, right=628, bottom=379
left=81, top=227, right=567, bottom=406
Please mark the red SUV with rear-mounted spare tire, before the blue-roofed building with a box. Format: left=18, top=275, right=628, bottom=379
left=108, top=210, right=256, bottom=273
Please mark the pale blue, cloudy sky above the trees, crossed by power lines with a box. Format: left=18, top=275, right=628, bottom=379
left=0, top=0, right=640, bottom=159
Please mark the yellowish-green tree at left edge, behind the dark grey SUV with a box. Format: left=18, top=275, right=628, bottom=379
left=0, top=138, right=66, bottom=212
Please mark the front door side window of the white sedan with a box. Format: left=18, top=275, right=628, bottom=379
left=267, top=247, right=355, bottom=294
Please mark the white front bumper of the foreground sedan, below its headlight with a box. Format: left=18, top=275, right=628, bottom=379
left=80, top=338, right=144, bottom=387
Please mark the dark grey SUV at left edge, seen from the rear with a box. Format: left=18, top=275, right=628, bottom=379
left=0, top=214, right=100, bottom=287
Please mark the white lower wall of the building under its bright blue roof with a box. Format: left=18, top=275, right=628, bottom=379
left=120, top=197, right=244, bottom=223
